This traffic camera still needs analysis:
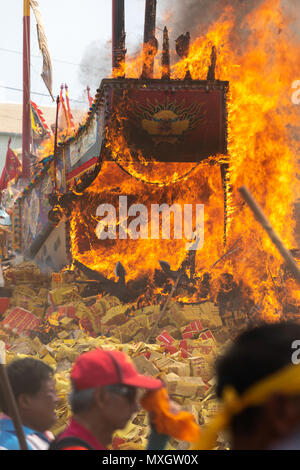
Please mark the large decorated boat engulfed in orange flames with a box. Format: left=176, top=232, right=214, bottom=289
left=14, top=0, right=297, bottom=326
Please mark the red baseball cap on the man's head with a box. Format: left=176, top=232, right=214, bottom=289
left=71, top=349, right=163, bottom=390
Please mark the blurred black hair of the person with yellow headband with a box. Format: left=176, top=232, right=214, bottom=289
left=216, top=322, right=300, bottom=433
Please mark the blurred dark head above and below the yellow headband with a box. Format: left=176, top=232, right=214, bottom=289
left=216, top=322, right=300, bottom=449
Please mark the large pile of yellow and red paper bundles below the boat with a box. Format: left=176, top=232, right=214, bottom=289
left=0, top=262, right=237, bottom=448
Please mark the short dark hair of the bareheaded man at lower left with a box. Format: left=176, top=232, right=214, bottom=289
left=0, top=357, right=54, bottom=413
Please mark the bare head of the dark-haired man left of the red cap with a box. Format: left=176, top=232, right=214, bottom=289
left=0, top=358, right=58, bottom=432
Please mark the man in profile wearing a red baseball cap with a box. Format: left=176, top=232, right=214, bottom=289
left=50, top=349, right=168, bottom=450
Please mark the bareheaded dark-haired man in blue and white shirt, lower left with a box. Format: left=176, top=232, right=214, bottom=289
left=0, top=358, right=58, bottom=450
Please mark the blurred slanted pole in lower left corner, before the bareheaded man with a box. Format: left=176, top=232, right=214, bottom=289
left=0, top=341, right=28, bottom=450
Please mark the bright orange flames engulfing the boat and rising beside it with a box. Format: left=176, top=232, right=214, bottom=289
left=71, top=0, right=300, bottom=319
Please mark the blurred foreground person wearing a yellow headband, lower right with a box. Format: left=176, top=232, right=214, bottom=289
left=195, top=322, right=300, bottom=450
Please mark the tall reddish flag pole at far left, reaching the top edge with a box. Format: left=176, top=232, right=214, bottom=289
left=22, top=0, right=31, bottom=180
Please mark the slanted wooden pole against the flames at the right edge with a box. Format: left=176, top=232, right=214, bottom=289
left=239, top=186, right=300, bottom=284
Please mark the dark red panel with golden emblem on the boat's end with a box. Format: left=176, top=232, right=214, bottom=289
left=112, top=82, right=227, bottom=162
